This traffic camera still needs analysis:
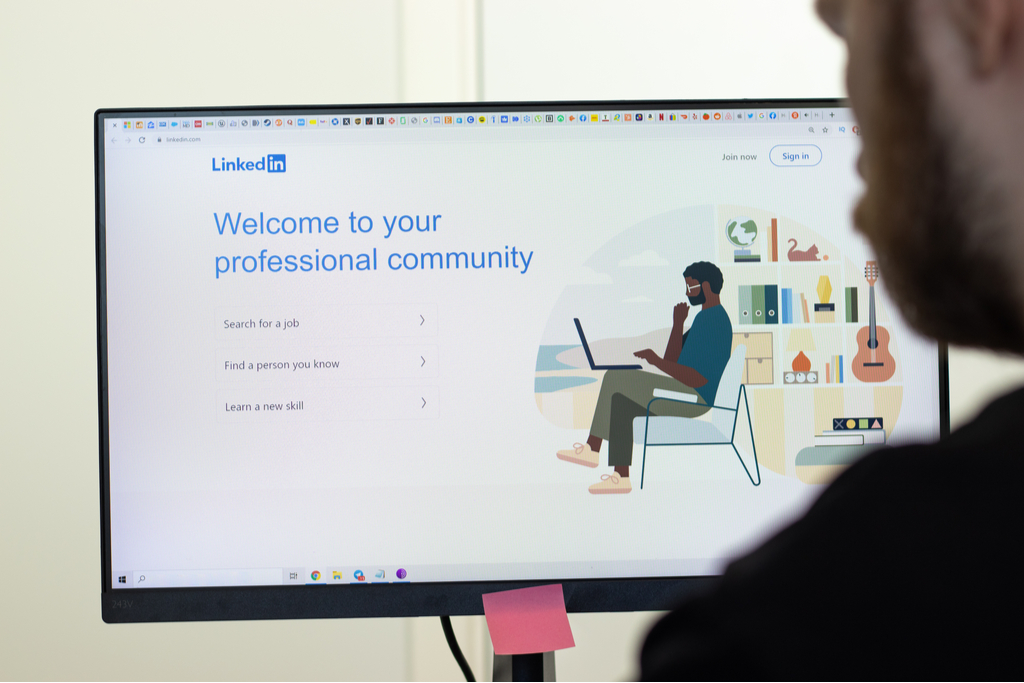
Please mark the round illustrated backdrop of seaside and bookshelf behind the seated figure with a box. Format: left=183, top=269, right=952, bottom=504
left=534, top=204, right=903, bottom=487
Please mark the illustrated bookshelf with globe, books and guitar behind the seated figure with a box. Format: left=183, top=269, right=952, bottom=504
left=716, top=205, right=902, bottom=483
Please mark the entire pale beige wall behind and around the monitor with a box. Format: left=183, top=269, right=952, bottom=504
left=0, top=0, right=1024, bottom=680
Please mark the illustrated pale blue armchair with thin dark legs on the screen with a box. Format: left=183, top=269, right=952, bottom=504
left=633, top=344, right=761, bottom=489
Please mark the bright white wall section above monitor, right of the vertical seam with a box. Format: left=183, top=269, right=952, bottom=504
left=481, top=0, right=845, bottom=100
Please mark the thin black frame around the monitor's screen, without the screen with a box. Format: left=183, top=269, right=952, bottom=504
left=94, top=98, right=949, bottom=624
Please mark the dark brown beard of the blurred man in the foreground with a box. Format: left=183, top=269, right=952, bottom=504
left=854, top=2, right=1024, bottom=353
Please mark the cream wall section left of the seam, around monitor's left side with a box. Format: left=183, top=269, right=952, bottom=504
left=0, top=0, right=475, bottom=680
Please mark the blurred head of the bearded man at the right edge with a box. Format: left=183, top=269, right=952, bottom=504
left=818, top=0, right=1024, bottom=352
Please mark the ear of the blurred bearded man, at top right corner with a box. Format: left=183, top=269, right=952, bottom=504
left=946, top=0, right=1021, bottom=77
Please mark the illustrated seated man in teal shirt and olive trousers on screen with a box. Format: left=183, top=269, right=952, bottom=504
left=558, top=261, right=732, bottom=494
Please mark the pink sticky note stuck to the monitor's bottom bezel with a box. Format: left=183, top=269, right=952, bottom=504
left=483, top=584, right=575, bottom=654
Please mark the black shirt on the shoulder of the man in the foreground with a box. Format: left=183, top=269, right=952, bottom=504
left=640, top=390, right=1024, bottom=680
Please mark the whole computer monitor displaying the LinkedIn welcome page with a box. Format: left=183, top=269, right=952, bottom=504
left=95, top=100, right=948, bottom=622
